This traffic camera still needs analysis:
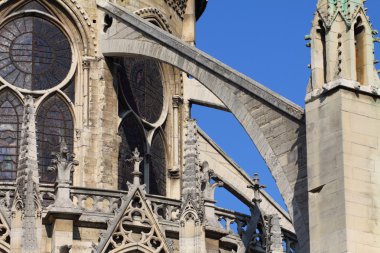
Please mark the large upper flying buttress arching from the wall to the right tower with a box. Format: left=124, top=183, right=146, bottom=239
left=98, top=1, right=308, bottom=251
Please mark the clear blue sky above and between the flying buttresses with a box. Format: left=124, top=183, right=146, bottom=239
left=192, top=0, right=380, bottom=211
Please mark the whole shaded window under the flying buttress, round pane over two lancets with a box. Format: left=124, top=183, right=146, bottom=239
left=113, top=57, right=166, bottom=195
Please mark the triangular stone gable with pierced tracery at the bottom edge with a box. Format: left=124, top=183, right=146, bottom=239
left=97, top=186, right=170, bottom=253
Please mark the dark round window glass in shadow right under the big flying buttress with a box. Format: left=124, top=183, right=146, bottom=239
left=119, top=57, right=164, bottom=123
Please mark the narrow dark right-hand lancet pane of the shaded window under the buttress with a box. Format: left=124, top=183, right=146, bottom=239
left=149, top=134, right=166, bottom=196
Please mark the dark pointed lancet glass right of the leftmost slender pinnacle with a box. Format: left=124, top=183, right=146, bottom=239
left=37, top=95, right=74, bottom=183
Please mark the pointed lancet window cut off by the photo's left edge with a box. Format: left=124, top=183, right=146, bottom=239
left=0, top=90, right=23, bottom=180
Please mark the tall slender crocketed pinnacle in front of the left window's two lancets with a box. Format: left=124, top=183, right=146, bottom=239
left=11, top=96, right=41, bottom=253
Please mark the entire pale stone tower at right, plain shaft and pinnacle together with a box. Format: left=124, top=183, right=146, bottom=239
left=306, top=0, right=380, bottom=253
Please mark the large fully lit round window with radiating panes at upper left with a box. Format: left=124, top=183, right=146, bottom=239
left=0, top=16, right=72, bottom=90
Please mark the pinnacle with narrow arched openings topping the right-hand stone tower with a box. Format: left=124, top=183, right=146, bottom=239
left=305, top=0, right=380, bottom=92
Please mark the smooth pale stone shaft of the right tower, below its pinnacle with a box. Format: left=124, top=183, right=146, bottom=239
left=306, top=89, right=380, bottom=253
